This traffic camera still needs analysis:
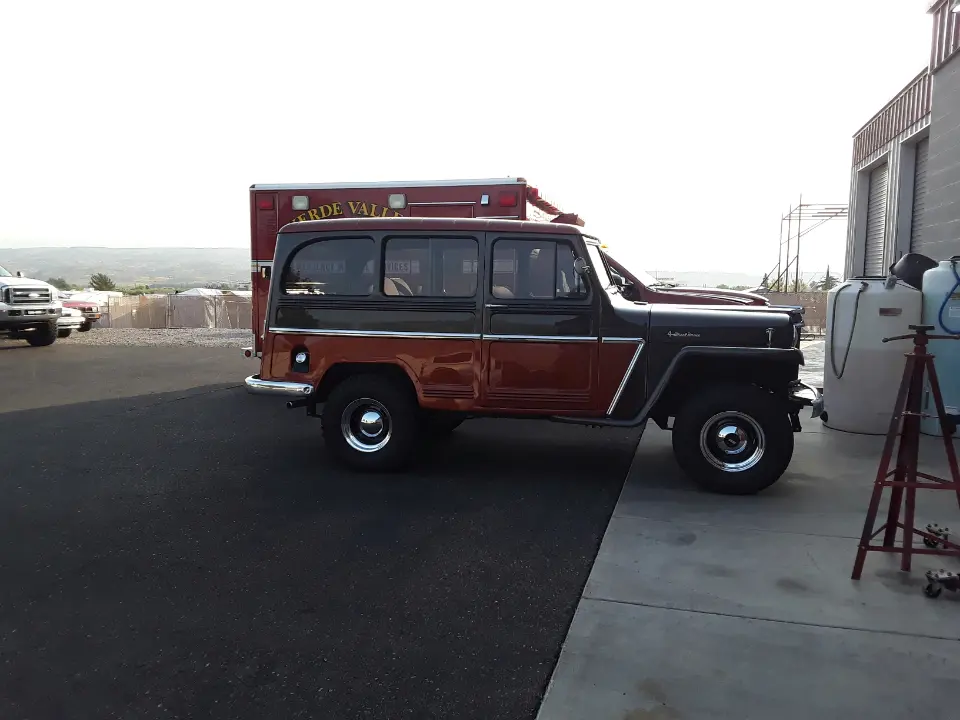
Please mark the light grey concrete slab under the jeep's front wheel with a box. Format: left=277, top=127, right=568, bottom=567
left=538, top=419, right=960, bottom=720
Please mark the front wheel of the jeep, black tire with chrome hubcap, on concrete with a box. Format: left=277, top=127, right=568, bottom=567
left=673, top=385, right=793, bottom=495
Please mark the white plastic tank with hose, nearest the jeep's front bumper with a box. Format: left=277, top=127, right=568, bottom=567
left=823, top=278, right=923, bottom=435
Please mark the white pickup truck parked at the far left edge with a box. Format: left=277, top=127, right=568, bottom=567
left=0, top=265, right=63, bottom=347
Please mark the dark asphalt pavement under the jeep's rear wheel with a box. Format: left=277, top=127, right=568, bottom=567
left=0, top=342, right=637, bottom=720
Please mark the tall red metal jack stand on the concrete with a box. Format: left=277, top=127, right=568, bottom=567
left=852, top=325, right=960, bottom=580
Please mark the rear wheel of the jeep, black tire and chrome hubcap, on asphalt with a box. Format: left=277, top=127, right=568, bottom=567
left=322, top=375, right=421, bottom=472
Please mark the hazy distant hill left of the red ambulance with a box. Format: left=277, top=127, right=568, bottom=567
left=0, top=247, right=250, bottom=286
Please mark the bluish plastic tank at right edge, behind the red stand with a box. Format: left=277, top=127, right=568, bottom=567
left=920, top=256, right=960, bottom=435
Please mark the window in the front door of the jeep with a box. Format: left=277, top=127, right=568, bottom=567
left=492, top=239, right=587, bottom=300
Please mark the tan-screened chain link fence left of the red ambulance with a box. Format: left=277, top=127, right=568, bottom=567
left=98, top=295, right=253, bottom=330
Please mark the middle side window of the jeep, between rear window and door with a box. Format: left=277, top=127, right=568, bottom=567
left=383, top=237, right=479, bottom=297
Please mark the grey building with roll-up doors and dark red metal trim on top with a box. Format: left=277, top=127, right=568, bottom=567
left=845, top=0, right=960, bottom=278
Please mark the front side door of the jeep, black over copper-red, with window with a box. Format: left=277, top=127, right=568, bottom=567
left=481, top=233, right=599, bottom=414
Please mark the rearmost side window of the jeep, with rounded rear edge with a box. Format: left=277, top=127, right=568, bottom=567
left=280, top=237, right=376, bottom=295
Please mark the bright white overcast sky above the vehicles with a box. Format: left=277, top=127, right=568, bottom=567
left=0, top=0, right=931, bottom=272
